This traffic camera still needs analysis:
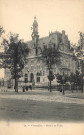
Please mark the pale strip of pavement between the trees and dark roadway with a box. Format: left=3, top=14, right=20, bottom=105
left=0, top=90, right=84, bottom=104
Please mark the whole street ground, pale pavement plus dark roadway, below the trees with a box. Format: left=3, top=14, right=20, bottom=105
left=0, top=90, right=84, bottom=122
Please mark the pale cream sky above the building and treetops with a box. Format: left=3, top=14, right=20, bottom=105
left=0, top=0, right=84, bottom=78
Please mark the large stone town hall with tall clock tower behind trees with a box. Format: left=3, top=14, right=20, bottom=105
left=5, top=17, right=77, bottom=85
